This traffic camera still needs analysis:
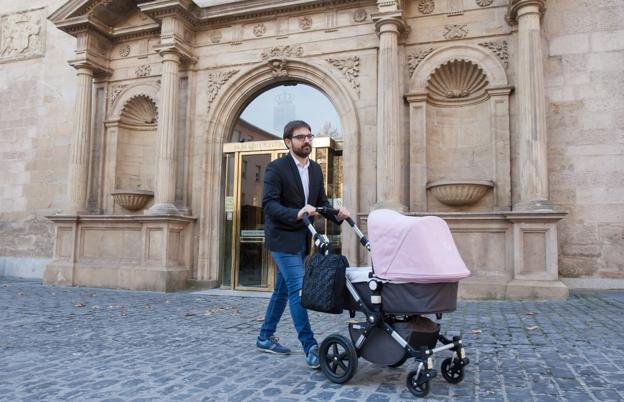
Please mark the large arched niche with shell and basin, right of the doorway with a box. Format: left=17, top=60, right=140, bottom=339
left=406, top=45, right=511, bottom=212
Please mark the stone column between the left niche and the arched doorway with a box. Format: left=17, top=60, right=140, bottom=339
left=145, top=48, right=180, bottom=215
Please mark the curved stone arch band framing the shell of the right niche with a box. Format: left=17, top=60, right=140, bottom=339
left=409, top=45, right=508, bottom=94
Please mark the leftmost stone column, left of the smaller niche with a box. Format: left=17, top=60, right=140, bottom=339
left=64, top=63, right=93, bottom=215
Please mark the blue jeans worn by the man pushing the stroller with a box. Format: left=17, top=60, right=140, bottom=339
left=259, top=251, right=317, bottom=355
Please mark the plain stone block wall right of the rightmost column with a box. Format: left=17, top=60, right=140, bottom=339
left=544, top=0, right=624, bottom=283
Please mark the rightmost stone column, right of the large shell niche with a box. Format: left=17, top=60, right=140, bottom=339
left=508, top=0, right=553, bottom=210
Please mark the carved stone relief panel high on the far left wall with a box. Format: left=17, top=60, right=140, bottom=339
left=0, top=9, right=46, bottom=63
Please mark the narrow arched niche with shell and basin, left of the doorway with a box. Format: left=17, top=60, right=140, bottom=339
left=102, top=84, right=158, bottom=214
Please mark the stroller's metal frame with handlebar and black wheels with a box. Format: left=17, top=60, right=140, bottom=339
left=303, top=208, right=470, bottom=397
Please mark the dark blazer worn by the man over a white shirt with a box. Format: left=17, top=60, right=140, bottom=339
left=262, top=153, right=341, bottom=254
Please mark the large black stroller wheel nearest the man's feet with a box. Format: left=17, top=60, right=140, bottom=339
left=319, top=334, right=357, bottom=384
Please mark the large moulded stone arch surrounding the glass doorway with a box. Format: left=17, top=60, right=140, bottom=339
left=196, top=59, right=359, bottom=280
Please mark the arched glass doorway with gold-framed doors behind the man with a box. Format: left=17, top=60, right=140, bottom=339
left=220, top=82, right=343, bottom=290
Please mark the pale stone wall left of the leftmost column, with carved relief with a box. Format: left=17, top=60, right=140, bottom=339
left=0, top=0, right=75, bottom=277
